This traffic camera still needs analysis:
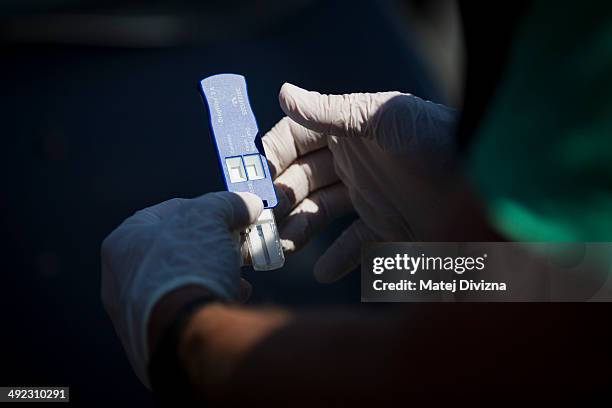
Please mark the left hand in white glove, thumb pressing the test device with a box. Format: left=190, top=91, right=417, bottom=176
left=101, top=192, right=263, bottom=386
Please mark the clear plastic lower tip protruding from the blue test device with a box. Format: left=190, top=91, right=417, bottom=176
left=245, top=208, right=285, bottom=271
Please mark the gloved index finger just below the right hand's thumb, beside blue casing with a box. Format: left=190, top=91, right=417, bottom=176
left=262, top=117, right=327, bottom=178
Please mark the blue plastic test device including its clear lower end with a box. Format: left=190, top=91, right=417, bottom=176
left=200, top=74, right=285, bottom=270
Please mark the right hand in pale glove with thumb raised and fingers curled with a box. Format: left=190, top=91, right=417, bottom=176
left=263, top=84, right=457, bottom=282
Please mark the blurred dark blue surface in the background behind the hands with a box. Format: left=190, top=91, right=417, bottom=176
left=0, top=1, right=438, bottom=405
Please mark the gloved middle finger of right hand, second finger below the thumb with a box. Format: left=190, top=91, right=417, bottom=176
left=274, top=149, right=338, bottom=220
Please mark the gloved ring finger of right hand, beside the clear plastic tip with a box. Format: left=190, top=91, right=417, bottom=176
left=280, top=183, right=353, bottom=253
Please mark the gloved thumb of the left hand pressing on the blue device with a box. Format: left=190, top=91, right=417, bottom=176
left=200, top=191, right=263, bottom=230
